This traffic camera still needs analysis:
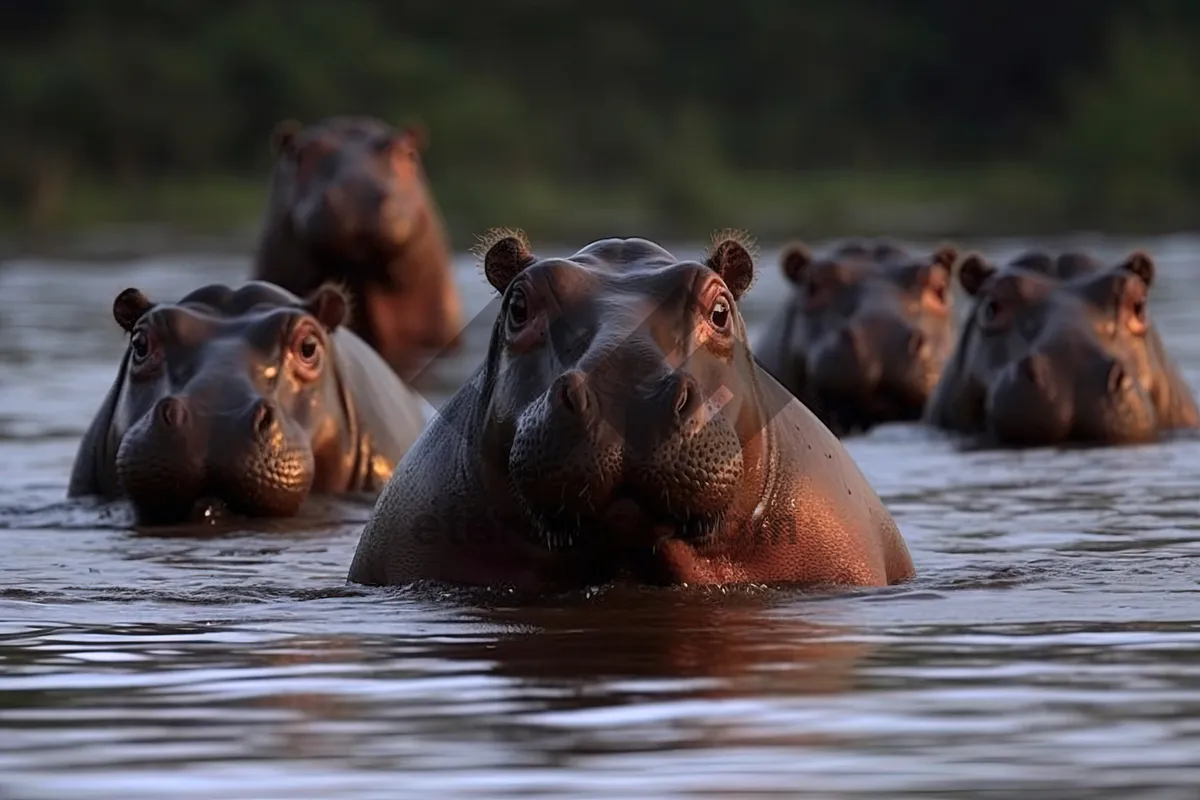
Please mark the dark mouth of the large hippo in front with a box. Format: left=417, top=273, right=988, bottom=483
left=521, top=489, right=724, bottom=551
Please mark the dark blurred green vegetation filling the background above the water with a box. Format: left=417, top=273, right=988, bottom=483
left=0, top=0, right=1200, bottom=246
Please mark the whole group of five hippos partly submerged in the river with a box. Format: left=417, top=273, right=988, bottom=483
left=68, top=118, right=1200, bottom=591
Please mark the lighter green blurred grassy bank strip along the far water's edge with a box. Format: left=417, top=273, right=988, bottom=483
left=0, top=166, right=1200, bottom=260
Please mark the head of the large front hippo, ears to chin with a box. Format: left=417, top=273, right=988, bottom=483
left=480, top=225, right=760, bottom=547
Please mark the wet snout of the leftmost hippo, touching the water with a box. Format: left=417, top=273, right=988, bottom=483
left=116, top=395, right=314, bottom=523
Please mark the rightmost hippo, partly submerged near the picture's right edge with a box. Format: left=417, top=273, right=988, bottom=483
left=925, top=251, right=1200, bottom=446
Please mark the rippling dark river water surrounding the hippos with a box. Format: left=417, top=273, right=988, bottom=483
left=0, top=237, right=1200, bottom=800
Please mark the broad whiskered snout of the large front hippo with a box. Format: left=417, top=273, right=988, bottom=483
left=508, top=369, right=744, bottom=544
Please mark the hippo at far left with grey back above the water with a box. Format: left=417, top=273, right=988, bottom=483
left=67, top=281, right=425, bottom=524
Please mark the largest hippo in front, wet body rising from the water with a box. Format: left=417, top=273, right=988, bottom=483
left=347, top=230, right=913, bottom=593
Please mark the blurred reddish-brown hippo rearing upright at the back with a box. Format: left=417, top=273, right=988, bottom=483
left=251, top=116, right=463, bottom=384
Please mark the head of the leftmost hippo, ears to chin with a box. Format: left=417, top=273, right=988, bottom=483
left=109, top=282, right=348, bottom=523
